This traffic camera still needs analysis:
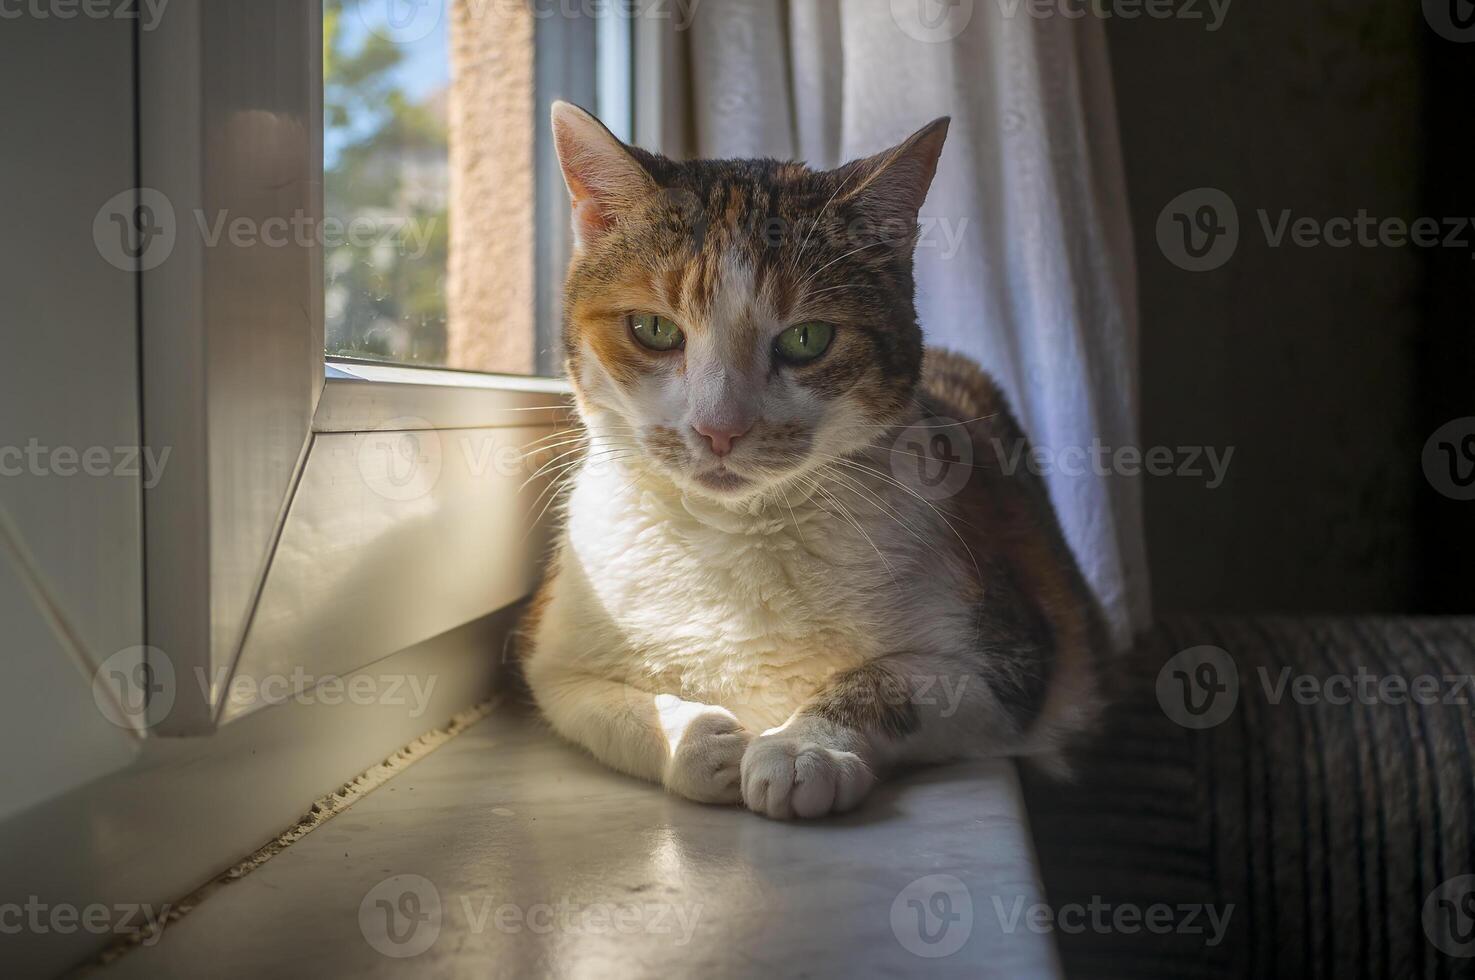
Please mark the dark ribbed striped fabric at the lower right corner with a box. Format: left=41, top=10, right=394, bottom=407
left=1025, top=618, right=1475, bottom=980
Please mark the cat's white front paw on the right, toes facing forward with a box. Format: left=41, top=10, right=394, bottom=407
left=742, top=732, right=876, bottom=821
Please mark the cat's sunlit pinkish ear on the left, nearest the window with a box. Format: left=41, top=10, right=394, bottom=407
left=553, top=102, right=656, bottom=245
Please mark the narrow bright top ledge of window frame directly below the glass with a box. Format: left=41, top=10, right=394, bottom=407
left=313, top=360, right=572, bottom=432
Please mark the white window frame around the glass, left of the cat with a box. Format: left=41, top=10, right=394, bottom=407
left=139, top=0, right=634, bottom=735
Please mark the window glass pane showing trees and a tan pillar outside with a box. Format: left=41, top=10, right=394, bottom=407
left=323, top=0, right=631, bottom=373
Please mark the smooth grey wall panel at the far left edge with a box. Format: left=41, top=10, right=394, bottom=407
left=0, top=18, right=143, bottom=816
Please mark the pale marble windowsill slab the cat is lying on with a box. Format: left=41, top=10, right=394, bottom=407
left=95, top=703, right=1061, bottom=980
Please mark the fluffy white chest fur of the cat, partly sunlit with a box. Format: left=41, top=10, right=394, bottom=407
left=552, top=466, right=898, bottom=731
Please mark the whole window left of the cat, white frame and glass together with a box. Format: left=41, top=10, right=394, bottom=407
left=136, top=0, right=581, bottom=735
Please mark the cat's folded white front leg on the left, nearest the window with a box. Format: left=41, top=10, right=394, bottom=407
left=528, top=664, right=749, bottom=803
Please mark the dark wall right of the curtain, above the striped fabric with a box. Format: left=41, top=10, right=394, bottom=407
left=1108, top=1, right=1475, bottom=611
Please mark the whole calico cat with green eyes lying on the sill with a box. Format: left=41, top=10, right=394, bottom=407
left=522, top=103, right=1106, bottom=818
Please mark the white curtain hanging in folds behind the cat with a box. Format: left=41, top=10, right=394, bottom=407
left=637, top=0, right=1151, bottom=646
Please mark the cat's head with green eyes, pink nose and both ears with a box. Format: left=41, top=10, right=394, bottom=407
left=553, top=102, right=947, bottom=502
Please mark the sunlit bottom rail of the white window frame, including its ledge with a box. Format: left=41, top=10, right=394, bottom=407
left=215, top=362, right=572, bottom=726
